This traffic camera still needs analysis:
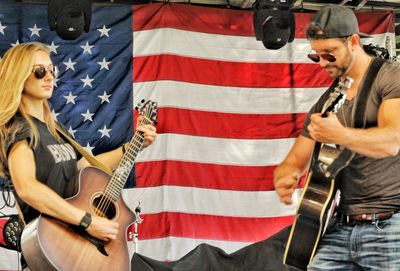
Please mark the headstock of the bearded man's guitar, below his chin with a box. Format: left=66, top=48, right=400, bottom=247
left=321, top=77, right=354, bottom=116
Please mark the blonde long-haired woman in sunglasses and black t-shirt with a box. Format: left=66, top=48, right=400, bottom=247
left=0, top=43, right=156, bottom=270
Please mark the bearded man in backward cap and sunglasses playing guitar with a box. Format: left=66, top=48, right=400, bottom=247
left=274, top=5, right=400, bottom=270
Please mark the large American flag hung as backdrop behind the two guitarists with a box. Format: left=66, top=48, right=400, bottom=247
left=0, top=3, right=394, bottom=270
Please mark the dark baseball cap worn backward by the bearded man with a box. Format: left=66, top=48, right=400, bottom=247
left=307, top=5, right=371, bottom=38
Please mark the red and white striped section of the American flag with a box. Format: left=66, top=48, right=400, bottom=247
left=130, top=3, right=394, bottom=261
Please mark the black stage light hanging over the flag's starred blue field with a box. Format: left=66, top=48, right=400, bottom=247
left=48, top=0, right=92, bottom=40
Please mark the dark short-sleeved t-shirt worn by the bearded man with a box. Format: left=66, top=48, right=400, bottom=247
left=302, top=60, right=400, bottom=214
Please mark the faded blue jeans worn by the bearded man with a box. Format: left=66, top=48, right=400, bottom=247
left=307, top=213, right=400, bottom=271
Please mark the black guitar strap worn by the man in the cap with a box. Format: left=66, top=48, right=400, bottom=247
left=325, top=58, right=385, bottom=178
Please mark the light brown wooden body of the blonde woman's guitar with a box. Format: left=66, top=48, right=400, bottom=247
left=21, top=167, right=135, bottom=271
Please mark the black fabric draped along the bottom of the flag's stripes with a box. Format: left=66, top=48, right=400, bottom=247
left=132, top=227, right=296, bottom=271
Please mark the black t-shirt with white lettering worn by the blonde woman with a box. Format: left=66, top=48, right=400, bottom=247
left=7, top=117, right=81, bottom=223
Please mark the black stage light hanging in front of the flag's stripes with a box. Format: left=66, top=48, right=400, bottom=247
left=253, top=0, right=295, bottom=50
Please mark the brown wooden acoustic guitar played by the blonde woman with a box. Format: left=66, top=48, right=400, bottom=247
left=21, top=101, right=157, bottom=271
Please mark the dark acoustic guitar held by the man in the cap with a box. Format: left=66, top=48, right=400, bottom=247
left=283, top=78, right=354, bottom=270
